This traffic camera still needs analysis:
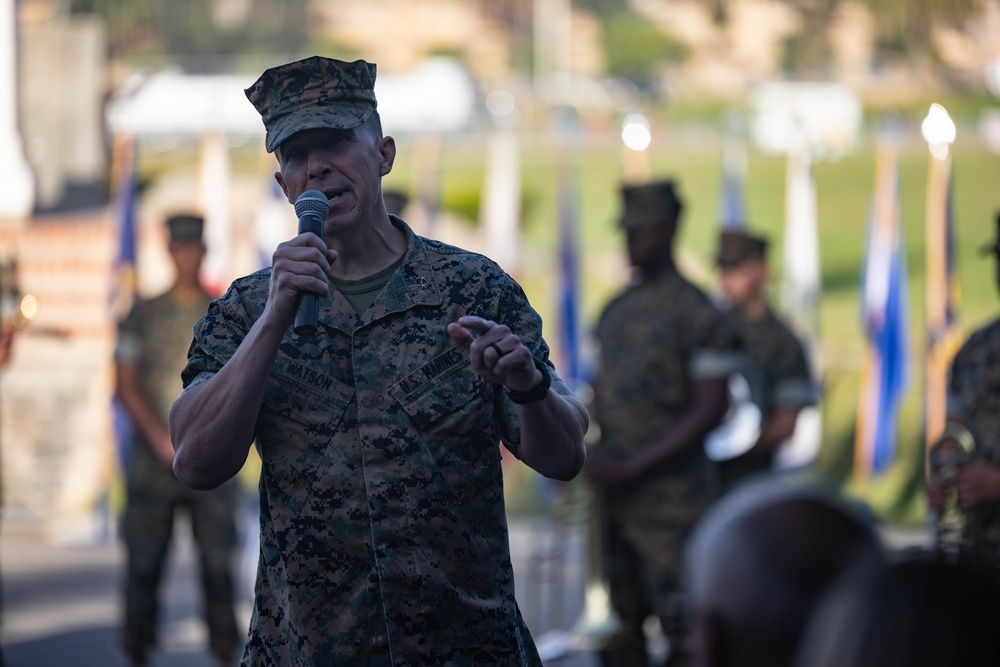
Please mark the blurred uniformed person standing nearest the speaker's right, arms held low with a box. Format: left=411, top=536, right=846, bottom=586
left=585, top=181, right=738, bottom=667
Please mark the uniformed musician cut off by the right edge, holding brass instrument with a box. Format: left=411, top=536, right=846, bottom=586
left=927, top=214, right=1000, bottom=567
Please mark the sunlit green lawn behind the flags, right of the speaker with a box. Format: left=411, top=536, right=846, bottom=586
left=384, top=116, right=1000, bottom=522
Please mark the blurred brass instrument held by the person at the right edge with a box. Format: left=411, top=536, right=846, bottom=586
left=928, top=422, right=983, bottom=561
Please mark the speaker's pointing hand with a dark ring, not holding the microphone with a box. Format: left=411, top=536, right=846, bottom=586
left=448, top=315, right=542, bottom=391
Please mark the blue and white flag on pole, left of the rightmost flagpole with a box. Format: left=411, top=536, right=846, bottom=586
left=854, top=141, right=911, bottom=479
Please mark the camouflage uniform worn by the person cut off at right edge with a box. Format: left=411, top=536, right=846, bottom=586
left=948, top=320, right=1000, bottom=567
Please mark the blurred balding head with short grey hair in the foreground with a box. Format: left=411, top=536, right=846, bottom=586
left=686, top=477, right=885, bottom=667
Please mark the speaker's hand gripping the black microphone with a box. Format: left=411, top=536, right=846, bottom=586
left=263, top=233, right=337, bottom=329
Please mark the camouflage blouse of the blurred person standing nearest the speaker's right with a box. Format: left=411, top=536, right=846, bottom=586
left=594, top=271, right=740, bottom=520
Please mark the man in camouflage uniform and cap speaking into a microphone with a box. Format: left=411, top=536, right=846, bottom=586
left=165, top=58, right=586, bottom=667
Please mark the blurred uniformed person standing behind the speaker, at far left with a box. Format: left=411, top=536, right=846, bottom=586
left=115, top=215, right=242, bottom=667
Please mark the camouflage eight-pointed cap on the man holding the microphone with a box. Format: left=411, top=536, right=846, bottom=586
left=244, top=56, right=378, bottom=153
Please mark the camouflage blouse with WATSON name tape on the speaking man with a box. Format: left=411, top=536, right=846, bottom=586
left=184, top=218, right=570, bottom=667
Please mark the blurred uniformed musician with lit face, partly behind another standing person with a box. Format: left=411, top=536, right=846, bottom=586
left=715, top=230, right=818, bottom=489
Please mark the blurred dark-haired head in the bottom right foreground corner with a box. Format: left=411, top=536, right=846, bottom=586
left=795, top=559, right=1000, bottom=667
